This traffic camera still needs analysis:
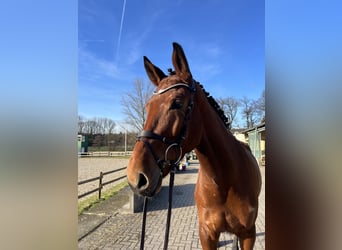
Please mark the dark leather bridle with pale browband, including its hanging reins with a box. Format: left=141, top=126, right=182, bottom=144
left=137, top=80, right=196, bottom=250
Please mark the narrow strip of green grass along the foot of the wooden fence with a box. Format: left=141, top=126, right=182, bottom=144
left=78, top=181, right=128, bottom=215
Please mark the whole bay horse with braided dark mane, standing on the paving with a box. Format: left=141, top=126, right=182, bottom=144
left=127, top=43, right=261, bottom=250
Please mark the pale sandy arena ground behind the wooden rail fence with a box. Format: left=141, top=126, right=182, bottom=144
left=78, top=157, right=128, bottom=201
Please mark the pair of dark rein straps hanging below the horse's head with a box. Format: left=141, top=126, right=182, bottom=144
left=140, top=164, right=177, bottom=250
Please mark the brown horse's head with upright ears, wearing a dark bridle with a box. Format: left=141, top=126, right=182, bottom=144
left=127, top=43, right=200, bottom=197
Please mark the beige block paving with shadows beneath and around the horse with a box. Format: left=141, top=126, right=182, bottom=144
left=78, top=164, right=265, bottom=250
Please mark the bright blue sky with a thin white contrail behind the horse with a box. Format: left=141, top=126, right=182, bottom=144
left=78, top=0, right=265, bottom=126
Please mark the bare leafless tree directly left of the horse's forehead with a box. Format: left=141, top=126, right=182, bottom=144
left=121, top=79, right=153, bottom=131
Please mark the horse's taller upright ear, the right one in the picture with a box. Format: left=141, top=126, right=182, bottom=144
left=172, top=43, right=192, bottom=82
